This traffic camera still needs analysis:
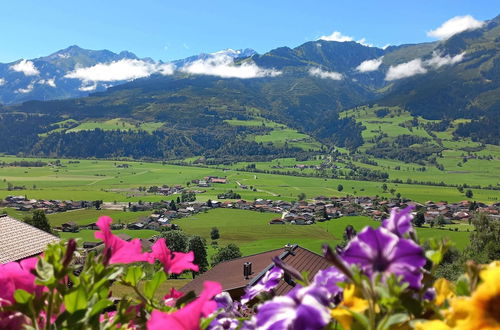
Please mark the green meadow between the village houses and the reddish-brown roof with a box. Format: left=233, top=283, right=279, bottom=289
left=175, top=209, right=469, bottom=255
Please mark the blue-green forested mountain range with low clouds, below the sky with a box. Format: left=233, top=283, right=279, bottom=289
left=0, top=16, right=500, bottom=158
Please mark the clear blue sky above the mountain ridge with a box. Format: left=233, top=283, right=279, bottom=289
left=0, top=0, right=500, bottom=62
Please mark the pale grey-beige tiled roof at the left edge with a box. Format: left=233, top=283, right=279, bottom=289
left=0, top=215, right=59, bottom=264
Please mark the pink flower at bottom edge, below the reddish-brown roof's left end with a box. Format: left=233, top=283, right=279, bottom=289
left=147, top=281, right=222, bottom=330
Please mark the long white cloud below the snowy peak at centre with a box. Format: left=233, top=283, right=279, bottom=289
left=180, top=54, right=281, bottom=79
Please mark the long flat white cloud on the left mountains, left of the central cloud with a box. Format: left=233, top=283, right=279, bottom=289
left=64, top=59, right=174, bottom=82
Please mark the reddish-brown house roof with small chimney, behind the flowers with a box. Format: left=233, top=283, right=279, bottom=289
left=180, top=244, right=331, bottom=300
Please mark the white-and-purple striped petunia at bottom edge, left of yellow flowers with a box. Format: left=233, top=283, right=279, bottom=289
left=255, top=286, right=330, bottom=330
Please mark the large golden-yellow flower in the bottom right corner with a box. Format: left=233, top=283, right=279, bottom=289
left=446, top=265, right=500, bottom=330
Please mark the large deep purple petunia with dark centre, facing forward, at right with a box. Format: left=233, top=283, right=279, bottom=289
left=342, top=227, right=425, bottom=288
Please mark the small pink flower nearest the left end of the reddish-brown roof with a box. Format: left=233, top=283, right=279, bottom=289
left=149, top=238, right=199, bottom=274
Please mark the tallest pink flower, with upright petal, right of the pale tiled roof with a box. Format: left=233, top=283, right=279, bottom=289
left=95, top=216, right=149, bottom=264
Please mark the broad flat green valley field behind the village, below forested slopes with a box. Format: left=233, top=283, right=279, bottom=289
left=0, top=157, right=500, bottom=203
